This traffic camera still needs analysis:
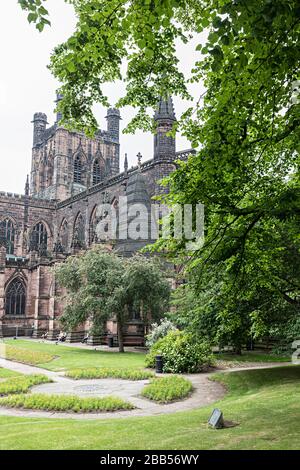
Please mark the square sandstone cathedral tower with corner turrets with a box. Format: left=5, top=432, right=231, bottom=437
left=30, top=94, right=121, bottom=201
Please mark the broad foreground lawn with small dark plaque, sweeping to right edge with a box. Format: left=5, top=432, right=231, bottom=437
left=0, top=366, right=300, bottom=450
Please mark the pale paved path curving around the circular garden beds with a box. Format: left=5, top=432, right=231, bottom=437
left=0, top=358, right=292, bottom=419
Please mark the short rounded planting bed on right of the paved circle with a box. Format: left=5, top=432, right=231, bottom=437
left=142, top=375, right=193, bottom=403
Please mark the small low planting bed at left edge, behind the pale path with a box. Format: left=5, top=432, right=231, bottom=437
left=0, top=343, right=55, bottom=365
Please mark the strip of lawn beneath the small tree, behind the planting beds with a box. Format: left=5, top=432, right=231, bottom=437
left=5, top=340, right=145, bottom=371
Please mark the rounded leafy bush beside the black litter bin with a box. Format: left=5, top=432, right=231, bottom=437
left=146, top=330, right=214, bottom=374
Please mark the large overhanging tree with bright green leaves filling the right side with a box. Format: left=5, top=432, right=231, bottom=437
left=20, top=0, right=300, bottom=348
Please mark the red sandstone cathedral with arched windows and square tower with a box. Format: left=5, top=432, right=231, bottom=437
left=0, top=96, right=190, bottom=345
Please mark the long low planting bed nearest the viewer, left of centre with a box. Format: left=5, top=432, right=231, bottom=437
left=0, top=393, right=134, bottom=413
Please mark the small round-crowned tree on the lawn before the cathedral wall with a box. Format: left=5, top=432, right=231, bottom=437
left=56, top=247, right=170, bottom=352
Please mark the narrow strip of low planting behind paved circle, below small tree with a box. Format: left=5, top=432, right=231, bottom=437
left=65, top=367, right=154, bottom=380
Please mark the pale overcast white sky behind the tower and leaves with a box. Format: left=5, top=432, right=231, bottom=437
left=0, top=0, right=203, bottom=194
